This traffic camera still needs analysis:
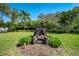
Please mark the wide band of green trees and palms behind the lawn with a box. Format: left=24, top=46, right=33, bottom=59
left=0, top=4, right=79, bottom=33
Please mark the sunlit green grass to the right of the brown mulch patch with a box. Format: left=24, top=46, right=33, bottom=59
left=48, top=33, right=79, bottom=56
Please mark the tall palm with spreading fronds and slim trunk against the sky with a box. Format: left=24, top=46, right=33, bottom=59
left=20, top=10, right=31, bottom=30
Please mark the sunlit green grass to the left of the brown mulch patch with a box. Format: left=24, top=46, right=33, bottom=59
left=0, top=32, right=32, bottom=55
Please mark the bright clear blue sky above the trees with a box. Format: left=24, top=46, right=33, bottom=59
left=3, top=3, right=79, bottom=22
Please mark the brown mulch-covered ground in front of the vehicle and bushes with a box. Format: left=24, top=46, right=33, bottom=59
left=18, top=44, right=64, bottom=56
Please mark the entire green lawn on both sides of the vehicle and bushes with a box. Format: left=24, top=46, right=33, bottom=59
left=0, top=32, right=79, bottom=56
